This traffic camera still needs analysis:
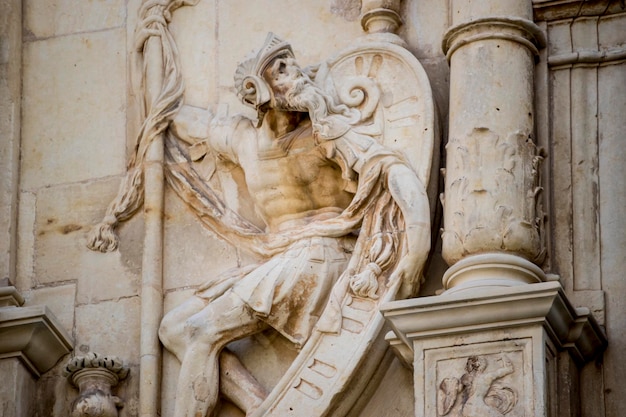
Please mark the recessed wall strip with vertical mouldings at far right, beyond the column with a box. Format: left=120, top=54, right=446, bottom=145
left=536, top=2, right=626, bottom=416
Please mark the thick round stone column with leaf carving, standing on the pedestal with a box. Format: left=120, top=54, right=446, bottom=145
left=442, top=0, right=545, bottom=292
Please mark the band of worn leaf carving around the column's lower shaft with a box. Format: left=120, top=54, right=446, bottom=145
left=443, top=129, right=545, bottom=264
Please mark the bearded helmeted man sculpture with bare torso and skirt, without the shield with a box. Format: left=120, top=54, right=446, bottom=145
left=117, top=34, right=430, bottom=417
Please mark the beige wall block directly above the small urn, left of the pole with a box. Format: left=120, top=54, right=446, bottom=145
left=76, top=297, right=141, bottom=364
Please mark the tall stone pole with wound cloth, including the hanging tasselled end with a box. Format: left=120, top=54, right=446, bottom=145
left=88, top=0, right=197, bottom=417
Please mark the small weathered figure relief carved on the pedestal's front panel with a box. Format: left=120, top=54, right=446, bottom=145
left=437, top=355, right=517, bottom=417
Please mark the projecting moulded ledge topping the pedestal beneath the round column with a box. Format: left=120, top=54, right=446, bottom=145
left=381, top=282, right=607, bottom=364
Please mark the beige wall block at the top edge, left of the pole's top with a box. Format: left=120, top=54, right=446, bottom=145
left=24, top=0, right=126, bottom=38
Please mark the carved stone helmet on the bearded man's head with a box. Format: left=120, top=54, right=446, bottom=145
left=235, top=32, right=294, bottom=111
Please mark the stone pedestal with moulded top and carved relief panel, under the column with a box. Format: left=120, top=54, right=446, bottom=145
left=382, top=282, right=606, bottom=417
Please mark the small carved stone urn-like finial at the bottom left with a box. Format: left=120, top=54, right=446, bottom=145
left=63, top=353, right=128, bottom=417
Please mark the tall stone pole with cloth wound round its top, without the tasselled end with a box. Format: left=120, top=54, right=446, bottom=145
left=136, top=0, right=196, bottom=417
